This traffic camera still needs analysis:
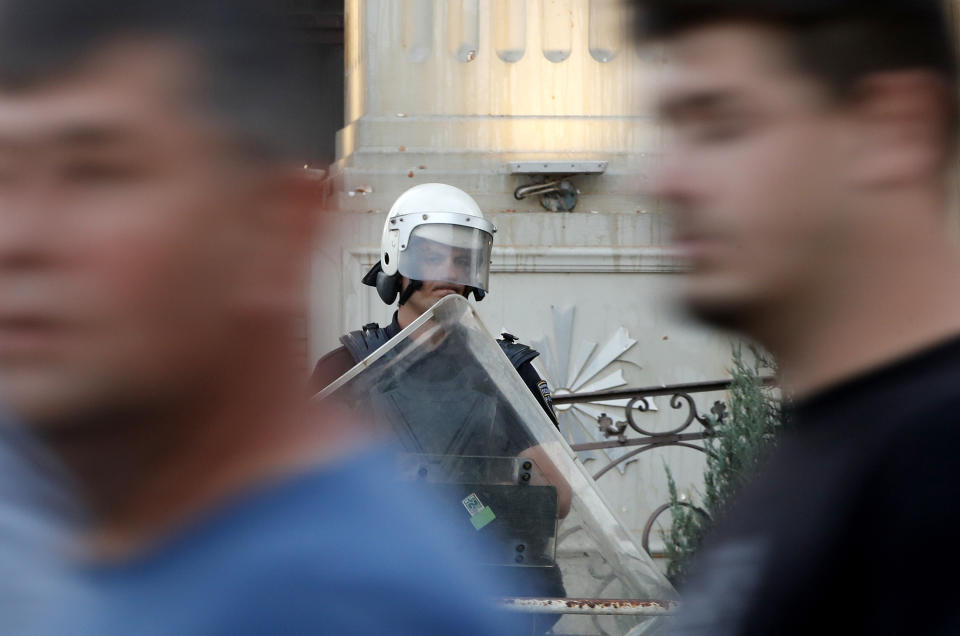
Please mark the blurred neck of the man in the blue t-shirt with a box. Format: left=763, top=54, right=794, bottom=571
left=48, top=348, right=367, bottom=559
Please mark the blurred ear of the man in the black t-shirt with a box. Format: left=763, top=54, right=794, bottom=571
left=849, top=71, right=952, bottom=188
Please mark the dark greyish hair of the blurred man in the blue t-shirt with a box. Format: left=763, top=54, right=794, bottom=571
left=0, top=0, right=322, bottom=159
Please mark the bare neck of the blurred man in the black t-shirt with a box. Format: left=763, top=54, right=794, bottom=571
left=751, top=199, right=960, bottom=398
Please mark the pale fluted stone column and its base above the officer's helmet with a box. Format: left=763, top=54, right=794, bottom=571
left=335, top=0, right=658, bottom=213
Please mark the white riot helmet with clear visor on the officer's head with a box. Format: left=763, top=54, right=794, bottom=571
left=363, top=183, right=497, bottom=305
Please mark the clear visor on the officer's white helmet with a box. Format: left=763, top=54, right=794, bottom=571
left=397, top=223, right=493, bottom=291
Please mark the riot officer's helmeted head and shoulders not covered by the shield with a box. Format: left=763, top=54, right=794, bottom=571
left=312, top=183, right=557, bottom=424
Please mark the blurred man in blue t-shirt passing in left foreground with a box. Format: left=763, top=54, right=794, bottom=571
left=0, top=0, right=510, bottom=634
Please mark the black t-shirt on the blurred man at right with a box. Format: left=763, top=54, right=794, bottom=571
left=673, top=339, right=960, bottom=636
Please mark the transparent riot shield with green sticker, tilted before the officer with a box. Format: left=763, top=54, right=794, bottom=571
left=318, top=295, right=676, bottom=634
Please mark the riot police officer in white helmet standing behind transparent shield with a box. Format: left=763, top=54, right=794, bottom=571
left=312, top=183, right=571, bottom=612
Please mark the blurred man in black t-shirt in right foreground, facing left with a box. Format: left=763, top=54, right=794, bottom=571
left=638, top=0, right=960, bottom=636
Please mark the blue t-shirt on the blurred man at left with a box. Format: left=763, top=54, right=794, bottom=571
left=52, top=450, right=524, bottom=636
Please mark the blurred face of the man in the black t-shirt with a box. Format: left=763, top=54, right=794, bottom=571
left=655, top=23, right=850, bottom=328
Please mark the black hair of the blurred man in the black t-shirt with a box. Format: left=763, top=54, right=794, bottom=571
left=635, top=0, right=957, bottom=138
